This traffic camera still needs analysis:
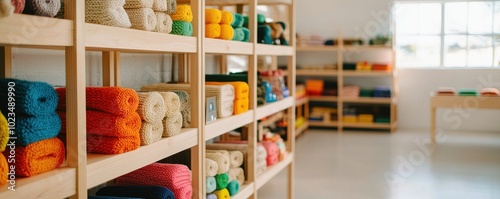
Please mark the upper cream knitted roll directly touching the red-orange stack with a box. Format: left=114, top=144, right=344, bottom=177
left=137, top=92, right=167, bottom=123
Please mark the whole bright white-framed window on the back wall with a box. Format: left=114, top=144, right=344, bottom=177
left=393, top=1, right=500, bottom=67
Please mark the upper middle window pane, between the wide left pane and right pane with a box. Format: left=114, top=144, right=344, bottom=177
left=444, top=2, right=467, bottom=33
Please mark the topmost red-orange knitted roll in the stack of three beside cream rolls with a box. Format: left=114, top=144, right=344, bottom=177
left=56, top=87, right=139, bottom=116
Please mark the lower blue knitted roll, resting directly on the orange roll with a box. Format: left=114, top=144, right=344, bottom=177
left=15, top=112, right=62, bottom=146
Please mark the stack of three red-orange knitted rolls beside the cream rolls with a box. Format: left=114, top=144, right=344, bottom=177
left=56, top=87, right=141, bottom=154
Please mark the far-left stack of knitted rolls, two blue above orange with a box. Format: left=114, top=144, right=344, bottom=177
left=0, top=79, right=65, bottom=177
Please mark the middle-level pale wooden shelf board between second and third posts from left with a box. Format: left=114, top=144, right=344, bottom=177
left=205, top=110, right=254, bottom=140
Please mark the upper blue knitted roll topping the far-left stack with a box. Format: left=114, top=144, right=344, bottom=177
left=0, top=79, right=59, bottom=116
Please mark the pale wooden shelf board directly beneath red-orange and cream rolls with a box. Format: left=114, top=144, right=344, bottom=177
left=87, top=129, right=198, bottom=188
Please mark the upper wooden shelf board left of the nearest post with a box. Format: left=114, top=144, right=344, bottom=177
left=0, top=14, right=73, bottom=47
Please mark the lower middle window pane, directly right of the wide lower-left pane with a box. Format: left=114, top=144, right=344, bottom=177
left=444, top=35, right=467, bottom=67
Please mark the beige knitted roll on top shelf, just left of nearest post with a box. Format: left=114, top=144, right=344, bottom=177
left=23, top=0, right=61, bottom=17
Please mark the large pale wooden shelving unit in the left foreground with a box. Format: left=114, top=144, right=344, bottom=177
left=0, top=0, right=295, bottom=199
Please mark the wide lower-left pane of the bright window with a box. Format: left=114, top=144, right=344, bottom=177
left=396, top=36, right=441, bottom=67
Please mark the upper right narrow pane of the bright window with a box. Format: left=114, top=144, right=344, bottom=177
left=469, top=2, right=493, bottom=34
